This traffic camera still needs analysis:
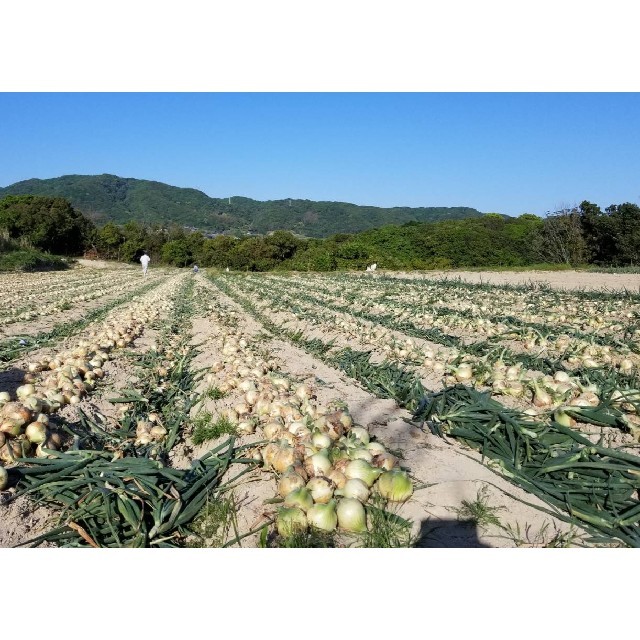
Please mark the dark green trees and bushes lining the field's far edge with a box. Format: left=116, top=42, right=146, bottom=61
left=0, top=196, right=640, bottom=271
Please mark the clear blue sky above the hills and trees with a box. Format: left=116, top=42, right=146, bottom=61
left=0, top=93, right=640, bottom=215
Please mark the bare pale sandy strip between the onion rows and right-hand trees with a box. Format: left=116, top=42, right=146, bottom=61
left=380, top=271, right=640, bottom=293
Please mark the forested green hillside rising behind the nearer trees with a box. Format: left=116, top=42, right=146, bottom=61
left=0, top=174, right=483, bottom=238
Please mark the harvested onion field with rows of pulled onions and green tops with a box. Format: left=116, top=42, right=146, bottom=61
left=0, top=267, right=640, bottom=548
